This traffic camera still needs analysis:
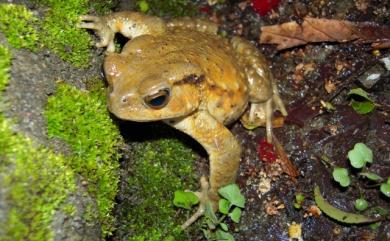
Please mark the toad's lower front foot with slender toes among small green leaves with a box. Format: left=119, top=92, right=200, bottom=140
left=181, top=177, right=219, bottom=229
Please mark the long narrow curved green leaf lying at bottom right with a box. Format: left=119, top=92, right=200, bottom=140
left=314, top=186, right=378, bottom=224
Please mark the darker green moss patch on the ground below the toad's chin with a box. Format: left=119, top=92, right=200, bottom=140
left=121, top=139, right=196, bottom=241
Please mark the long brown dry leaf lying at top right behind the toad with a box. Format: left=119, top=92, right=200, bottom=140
left=260, top=17, right=390, bottom=50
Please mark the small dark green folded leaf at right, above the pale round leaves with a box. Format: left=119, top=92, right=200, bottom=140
left=348, top=88, right=375, bottom=115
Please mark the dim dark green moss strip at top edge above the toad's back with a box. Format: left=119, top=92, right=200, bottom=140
left=137, top=0, right=198, bottom=17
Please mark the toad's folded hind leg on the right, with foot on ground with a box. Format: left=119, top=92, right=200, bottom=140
left=231, top=37, right=287, bottom=142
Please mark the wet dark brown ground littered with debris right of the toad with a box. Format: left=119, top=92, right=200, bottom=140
left=203, top=1, right=390, bottom=240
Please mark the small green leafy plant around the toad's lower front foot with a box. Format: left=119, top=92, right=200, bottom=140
left=174, top=184, right=245, bottom=241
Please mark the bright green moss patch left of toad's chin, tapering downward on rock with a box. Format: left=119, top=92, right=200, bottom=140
left=46, top=84, right=120, bottom=235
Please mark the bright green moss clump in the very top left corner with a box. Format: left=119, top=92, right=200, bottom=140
left=0, top=3, right=38, bottom=50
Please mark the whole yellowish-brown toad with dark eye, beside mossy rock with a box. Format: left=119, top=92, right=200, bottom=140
left=79, top=12, right=287, bottom=228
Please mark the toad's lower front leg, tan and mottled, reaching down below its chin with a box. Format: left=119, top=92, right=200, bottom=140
left=166, top=111, right=241, bottom=228
